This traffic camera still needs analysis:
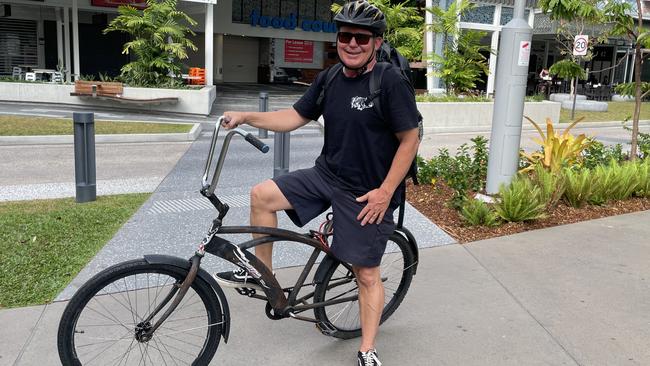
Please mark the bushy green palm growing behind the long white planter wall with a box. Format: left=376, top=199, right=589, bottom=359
left=104, top=0, right=197, bottom=86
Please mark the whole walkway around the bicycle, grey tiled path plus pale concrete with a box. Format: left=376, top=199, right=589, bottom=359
left=0, top=87, right=650, bottom=366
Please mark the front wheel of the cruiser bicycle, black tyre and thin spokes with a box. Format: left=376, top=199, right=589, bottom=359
left=57, top=259, right=222, bottom=366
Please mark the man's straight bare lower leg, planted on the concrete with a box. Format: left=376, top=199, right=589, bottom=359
left=354, top=267, right=384, bottom=352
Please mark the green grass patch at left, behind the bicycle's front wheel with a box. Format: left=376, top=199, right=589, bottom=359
left=0, top=193, right=150, bottom=308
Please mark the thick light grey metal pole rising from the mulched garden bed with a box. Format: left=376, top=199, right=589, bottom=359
left=486, top=0, right=533, bottom=194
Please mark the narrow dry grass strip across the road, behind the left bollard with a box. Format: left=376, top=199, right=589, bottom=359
left=0, top=116, right=192, bottom=136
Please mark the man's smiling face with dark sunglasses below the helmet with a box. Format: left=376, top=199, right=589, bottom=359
left=336, top=26, right=381, bottom=69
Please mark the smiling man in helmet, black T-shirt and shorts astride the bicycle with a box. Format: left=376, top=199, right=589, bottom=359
left=216, top=0, right=420, bottom=366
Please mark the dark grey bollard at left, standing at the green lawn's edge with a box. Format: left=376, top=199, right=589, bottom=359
left=72, top=112, right=97, bottom=203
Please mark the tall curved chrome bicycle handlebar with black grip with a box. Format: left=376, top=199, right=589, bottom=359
left=201, top=116, right=269, bottom=197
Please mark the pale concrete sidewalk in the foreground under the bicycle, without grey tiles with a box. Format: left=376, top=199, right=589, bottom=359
left=0, top=211, right=650, bottom=366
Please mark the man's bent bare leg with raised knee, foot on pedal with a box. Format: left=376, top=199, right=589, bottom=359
left=250, top=179, right=291, bottom=270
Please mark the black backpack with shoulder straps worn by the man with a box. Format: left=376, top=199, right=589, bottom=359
left=316, top=41, right=423, bottom=227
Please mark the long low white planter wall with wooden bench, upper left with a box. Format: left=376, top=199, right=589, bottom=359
left=0, top=82, right=217, bottom=116
